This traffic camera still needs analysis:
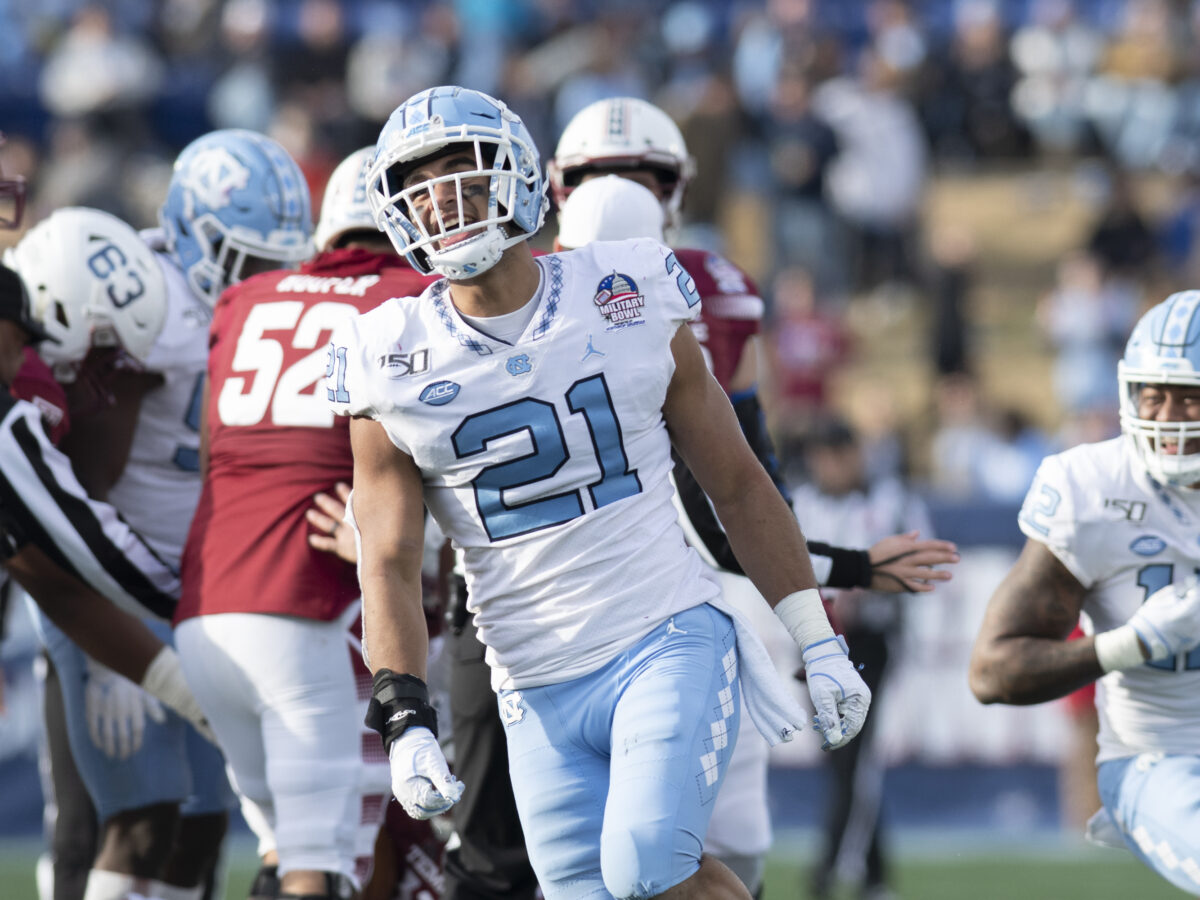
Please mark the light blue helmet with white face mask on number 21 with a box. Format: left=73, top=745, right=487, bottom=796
left=367, top=86, right=550, bottom=281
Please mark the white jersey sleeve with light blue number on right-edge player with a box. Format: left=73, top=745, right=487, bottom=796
left=1016, top=455, right=1103, bottom=587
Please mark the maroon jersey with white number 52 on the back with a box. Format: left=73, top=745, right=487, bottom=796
left=175, top=250, right=432, bottom=623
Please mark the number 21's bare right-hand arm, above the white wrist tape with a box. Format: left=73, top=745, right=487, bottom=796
left=662, top=329, right=817, bottom=606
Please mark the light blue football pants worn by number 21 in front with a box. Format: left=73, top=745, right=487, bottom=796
left=499, top=605, right=740, bottom=900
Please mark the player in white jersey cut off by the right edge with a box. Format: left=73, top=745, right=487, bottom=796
left=970, top=290, right=1200, bottom=895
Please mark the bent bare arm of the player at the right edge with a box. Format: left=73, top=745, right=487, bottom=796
left=968, top=540, right=1103, bottom=704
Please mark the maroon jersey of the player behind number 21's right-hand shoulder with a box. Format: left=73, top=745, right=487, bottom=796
left=674, top=250, right=763, bottom=394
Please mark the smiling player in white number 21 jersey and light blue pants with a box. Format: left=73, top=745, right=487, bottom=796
left=326, top=86, right=870, bottom=900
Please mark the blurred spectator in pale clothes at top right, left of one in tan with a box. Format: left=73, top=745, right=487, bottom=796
left=1012, top=0, right=1104, bottom=155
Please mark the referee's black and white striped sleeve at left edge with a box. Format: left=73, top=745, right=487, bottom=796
left=0, top=391, right=179, bottom=622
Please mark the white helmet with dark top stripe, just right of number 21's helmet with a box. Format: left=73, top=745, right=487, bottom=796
left=547, top=97, right=696, bottom=234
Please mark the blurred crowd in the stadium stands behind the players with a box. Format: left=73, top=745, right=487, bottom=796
left=7, top=0, right=1200, bottom=503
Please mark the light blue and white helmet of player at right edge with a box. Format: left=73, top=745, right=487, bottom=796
left=1117, top=290, right=1200, bottom=486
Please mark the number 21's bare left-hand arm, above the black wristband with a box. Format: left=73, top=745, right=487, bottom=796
left=350, top=419, right=428, bottom=679
